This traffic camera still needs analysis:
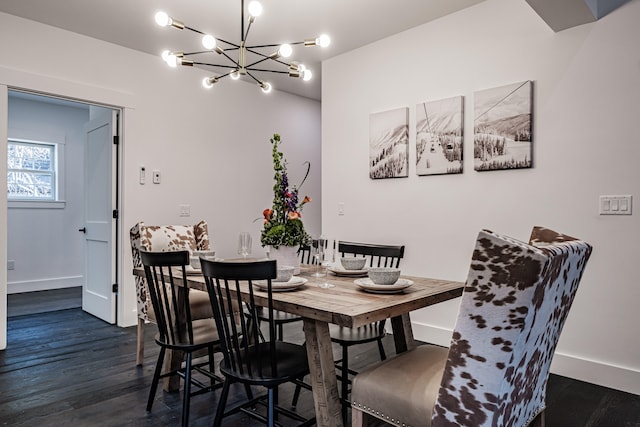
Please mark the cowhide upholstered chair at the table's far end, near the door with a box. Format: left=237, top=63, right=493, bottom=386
left=129, top=220, right=213, bottom=365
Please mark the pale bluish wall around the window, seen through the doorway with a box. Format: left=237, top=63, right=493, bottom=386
left=7, top=97, right=89, bottom=294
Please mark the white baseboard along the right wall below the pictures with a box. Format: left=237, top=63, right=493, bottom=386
left=411, top=322, right=640, bottom=395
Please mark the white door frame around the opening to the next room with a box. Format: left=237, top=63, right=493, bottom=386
left=0, top=66, right=136, bottom=350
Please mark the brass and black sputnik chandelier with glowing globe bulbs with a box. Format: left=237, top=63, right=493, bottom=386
left=155, top=0, right=331, bottom=93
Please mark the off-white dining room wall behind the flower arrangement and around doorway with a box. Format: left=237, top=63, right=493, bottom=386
left=0, top=14, right=321, bottom=334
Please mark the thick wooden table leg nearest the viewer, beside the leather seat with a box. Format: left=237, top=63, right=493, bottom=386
left=304, top=318, right=343, bottom=427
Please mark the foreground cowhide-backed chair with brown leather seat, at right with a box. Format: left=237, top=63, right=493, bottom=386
left=352, top=227, right=591, bottom=427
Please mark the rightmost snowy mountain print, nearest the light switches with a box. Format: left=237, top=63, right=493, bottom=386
left=473, top=81, right=533, bottom=171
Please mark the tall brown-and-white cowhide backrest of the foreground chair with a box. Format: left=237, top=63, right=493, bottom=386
left=431, top=229, right=591, bottom=427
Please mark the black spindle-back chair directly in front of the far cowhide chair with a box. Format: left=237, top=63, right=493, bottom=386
left=140, top=250, right=223, bottom=427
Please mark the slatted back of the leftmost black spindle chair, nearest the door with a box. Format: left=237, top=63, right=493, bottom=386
left=140, top=249, right=194, bottom=345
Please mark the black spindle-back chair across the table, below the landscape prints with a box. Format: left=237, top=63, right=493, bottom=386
left=329, top=241, right=404, bottom=424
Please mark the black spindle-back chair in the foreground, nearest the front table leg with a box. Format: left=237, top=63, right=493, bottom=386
left=201, top=259, right=315, bottom=426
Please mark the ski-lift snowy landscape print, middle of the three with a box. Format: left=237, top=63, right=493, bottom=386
left=416, top=96, right=463, bottom=175
